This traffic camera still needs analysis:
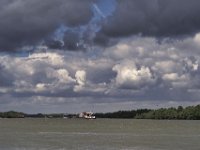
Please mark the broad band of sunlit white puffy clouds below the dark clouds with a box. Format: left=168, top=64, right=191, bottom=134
left=0, top=37, right=200, bottom=112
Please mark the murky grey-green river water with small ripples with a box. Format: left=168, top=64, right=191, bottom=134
left=0, top=119, right=200, bottom=150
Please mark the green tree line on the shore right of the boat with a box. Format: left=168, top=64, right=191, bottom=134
left=95, top=105, right=200, bottom=120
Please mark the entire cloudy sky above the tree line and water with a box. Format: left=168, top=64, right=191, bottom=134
left=0, top=0, right=200, bottom=113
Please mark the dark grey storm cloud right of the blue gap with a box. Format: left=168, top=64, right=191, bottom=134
left=101, top=0, right=200, bottom=38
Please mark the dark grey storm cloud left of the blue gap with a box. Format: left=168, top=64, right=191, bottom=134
left=0, top=0, right=93, bottom=51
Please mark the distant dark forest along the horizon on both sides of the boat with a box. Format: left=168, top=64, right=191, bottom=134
left=0, top=105, right=200, bottom=120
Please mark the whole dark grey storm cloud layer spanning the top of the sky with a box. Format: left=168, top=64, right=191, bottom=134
left=0, top=0, right=200, bottom=51
